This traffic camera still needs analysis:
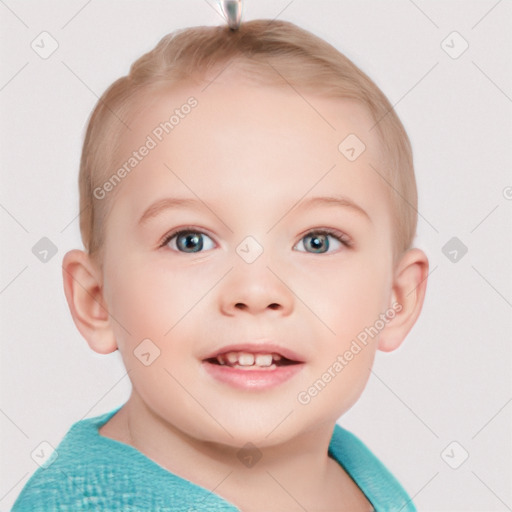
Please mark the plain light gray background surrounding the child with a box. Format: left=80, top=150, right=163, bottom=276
left=0, top=0, right=512, bottom=512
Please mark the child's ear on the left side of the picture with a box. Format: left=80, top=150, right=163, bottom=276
left=62, top=249, right=117, bottom=354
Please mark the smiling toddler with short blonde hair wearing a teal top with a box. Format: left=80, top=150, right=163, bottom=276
left=13, top=16, right=428, bottom=512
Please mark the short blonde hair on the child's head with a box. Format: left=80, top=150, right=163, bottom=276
left=79, top=20, right=417, bottom=265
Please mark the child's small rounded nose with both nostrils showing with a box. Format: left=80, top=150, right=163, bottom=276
left=219, top=258, right=295, bottom=316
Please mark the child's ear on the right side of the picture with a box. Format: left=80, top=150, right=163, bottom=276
left=377, top=249, right=428, bottom=352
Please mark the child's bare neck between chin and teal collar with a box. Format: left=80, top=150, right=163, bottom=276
left=100, top=392, right=369, bottom=512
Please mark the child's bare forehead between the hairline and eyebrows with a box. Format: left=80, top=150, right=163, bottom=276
left=107, top=75, right=383, bottom=226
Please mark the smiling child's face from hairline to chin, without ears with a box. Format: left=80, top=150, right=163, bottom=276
left=99, top=77, right=393, bottom=446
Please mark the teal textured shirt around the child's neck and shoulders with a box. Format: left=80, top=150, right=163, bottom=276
left=12, top=407, right=416, bottom=512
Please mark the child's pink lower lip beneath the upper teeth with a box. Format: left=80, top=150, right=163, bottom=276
left=203, top=361, right=304, bottom=390
